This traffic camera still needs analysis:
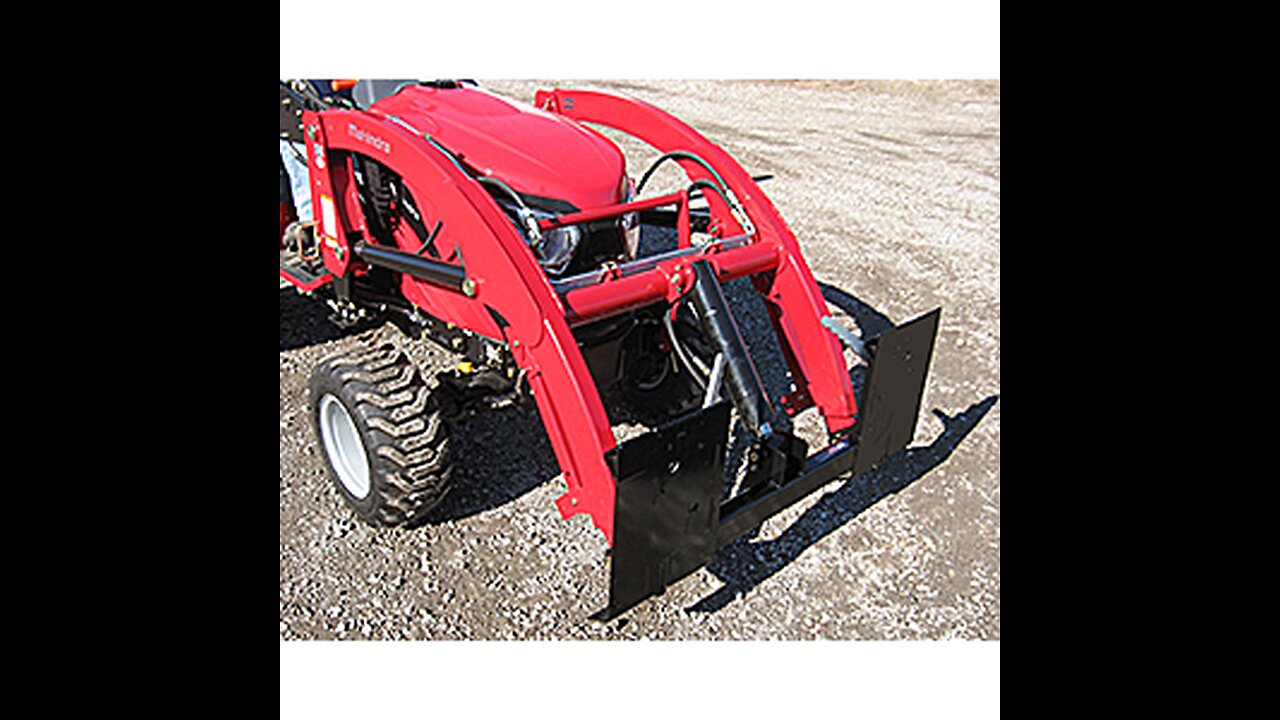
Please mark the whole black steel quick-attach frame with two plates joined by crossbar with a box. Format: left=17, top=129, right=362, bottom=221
left=593, top=304, right=941, bottom=620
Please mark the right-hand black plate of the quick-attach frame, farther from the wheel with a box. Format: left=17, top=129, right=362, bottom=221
left=854, top=309, right=942, bottom=475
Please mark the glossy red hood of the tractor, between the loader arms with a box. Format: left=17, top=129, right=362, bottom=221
left=372, top=86, right=626, bottom=210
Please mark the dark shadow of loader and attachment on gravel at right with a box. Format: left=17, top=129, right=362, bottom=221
left=686, top=283, right=1000, bottom=612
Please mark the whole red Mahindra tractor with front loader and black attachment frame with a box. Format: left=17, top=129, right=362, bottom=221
left=280, top=81, right=938, bottom=619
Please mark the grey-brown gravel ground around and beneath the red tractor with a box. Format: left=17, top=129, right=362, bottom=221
left=280, top=81, right=1000, bottom=639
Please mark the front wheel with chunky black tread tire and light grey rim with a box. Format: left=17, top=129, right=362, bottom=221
left=310, top=343, right=456, bottom=525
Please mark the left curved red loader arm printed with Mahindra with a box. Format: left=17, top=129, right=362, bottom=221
left=305, top=110, right=614, bottom=543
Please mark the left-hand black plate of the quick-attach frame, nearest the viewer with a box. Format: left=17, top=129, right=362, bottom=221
left=594, top=402, right=730, bottom=620
